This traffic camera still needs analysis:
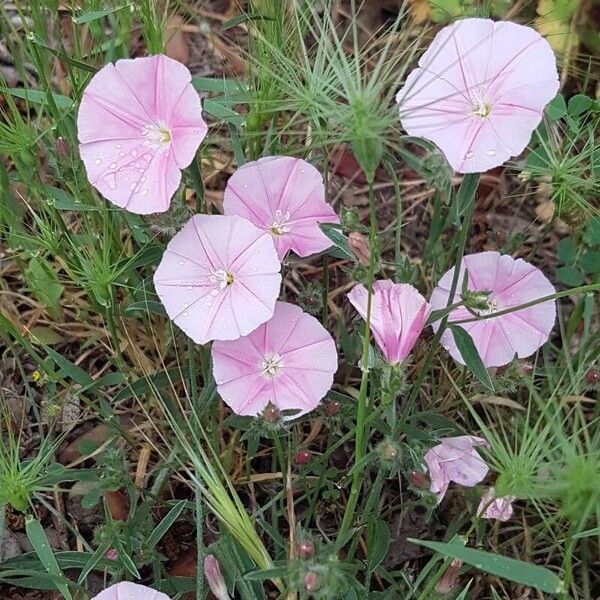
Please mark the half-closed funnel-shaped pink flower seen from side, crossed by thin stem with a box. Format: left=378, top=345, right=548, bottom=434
left=348, top=279, right=431, bottom=364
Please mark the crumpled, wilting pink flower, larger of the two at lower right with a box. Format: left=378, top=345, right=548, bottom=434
left=425, top=435, right=489, bottom=504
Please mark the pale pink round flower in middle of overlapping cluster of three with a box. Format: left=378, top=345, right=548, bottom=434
left=154, top=215, right=281, bottom=344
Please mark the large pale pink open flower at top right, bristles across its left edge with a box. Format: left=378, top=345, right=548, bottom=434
left=396, top=19, right=558, bottom=173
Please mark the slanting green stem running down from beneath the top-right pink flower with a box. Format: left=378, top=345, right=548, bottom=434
left=402, top=173, right=479, bottom=418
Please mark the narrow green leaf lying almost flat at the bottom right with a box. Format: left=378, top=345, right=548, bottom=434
left=408, top=538, right=564, bottom=594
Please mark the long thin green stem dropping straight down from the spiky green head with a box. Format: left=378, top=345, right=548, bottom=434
left=337, top=173, right=377, bottom=544
